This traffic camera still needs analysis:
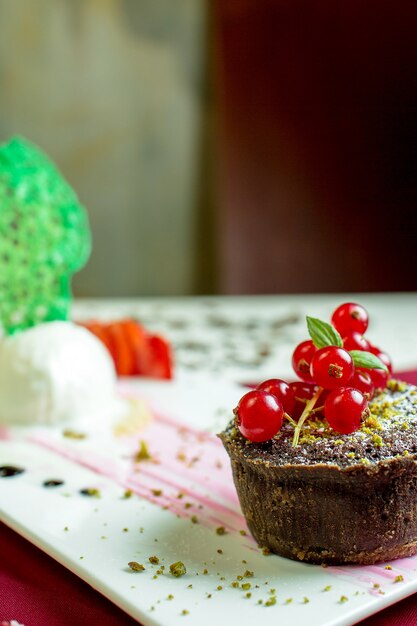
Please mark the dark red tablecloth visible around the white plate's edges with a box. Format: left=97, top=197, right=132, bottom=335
left=0, top=371, right=417, bottom=626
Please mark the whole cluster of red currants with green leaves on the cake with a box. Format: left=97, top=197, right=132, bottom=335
left=234, top=302, right=392, bottom=446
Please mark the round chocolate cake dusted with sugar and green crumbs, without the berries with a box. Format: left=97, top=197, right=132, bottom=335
left=219, top=380, right=417, bottom=564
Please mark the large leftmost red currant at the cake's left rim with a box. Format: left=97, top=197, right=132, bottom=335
left=234, top=389, right=284, bottom=442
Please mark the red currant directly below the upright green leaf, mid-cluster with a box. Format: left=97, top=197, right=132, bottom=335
left=310, top=346, right=355, bottom=389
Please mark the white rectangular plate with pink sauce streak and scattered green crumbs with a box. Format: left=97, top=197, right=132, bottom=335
left=0, top=379, right=417, bottom=626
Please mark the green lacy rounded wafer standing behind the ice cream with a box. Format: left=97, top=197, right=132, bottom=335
left=0, top=137, right=91, bottom=334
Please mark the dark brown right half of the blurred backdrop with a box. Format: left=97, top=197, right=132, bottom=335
left=214, top=0, right=417, bottom=293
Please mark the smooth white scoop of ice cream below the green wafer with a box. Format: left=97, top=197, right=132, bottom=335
left=0, top=322, right=125, bottom=425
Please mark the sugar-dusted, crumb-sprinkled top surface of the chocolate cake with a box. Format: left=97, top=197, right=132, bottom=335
left=220, top=380, right=417, bottom=469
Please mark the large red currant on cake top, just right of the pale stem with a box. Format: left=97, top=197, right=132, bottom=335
left=324, top=387, right=368, bottom=435
